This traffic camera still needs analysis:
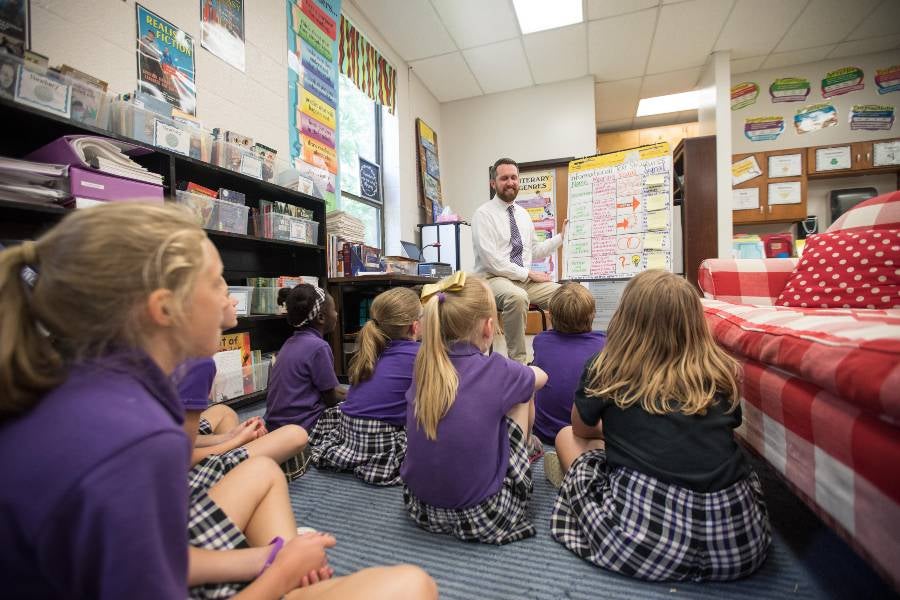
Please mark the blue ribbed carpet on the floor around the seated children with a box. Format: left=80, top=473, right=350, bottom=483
left=290, top=461, right=820, bottom=600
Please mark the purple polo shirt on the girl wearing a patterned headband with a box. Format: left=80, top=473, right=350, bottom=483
left=264, top=327, right=338, bottom=431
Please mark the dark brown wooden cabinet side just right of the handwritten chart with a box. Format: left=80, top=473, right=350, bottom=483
left=672, top=135, right=719, bottom=286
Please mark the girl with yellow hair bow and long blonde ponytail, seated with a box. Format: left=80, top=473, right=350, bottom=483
left=400, top=272, right=547, bottom=544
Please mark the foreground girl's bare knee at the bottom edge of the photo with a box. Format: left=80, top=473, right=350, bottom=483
left=285, top=565, right=438, bottom=600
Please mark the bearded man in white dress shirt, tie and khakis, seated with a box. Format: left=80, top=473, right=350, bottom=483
left=472, top=158, right=568, bottom=363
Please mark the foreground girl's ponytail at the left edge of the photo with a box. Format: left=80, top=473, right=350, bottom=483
left=0, top=241, right=64, bottom=421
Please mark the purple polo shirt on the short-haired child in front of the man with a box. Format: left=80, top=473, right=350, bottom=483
left=534, top=329, right=606, bottom=444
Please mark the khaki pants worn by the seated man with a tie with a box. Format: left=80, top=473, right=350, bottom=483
left=487, top=277, right=559, bottom=364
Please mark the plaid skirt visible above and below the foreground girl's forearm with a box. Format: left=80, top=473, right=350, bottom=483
left=188, top=491, right=249, bottom=600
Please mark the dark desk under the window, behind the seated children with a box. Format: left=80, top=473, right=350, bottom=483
left=328, top=273, right=437, bottom=375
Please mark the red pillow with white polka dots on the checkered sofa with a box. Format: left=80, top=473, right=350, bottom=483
left=775, top=229, right=900, bottom=309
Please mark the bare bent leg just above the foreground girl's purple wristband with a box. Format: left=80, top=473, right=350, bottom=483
left=209, top=456, right=297, bottom=546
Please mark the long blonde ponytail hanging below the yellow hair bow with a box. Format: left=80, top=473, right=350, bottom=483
left=415, top=295, right=459, bottom=440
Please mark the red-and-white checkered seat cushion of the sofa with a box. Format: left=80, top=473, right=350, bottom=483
left=703, top=299, right=900, bottom=422
